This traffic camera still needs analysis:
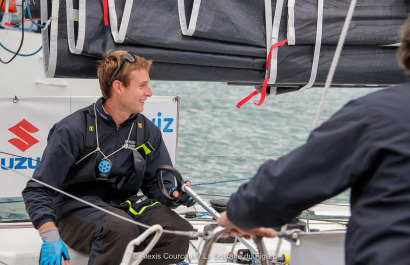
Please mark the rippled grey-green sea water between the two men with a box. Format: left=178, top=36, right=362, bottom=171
left=151, top=81, right=377, bottom=203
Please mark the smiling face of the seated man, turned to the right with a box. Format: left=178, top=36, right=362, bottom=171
left=122, top=69, right=152, bottom=113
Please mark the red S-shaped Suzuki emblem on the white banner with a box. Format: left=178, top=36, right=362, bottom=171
left=9, top=119, right=39, bottom=152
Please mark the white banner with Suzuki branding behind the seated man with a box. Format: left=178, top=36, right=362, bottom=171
left=0, top=97, right=179, bottom=198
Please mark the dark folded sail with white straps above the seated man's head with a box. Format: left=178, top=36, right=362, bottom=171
left=41, top=0, right=410, bottom=90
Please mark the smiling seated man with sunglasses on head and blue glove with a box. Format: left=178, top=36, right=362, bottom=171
left=23, top=51, right=195, bottom=265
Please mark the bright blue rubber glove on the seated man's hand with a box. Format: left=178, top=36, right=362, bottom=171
left=40, top=238, right=70, bottom=265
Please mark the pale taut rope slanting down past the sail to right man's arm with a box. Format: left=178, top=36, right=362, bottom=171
left=313, top=0, right=357, bottom=129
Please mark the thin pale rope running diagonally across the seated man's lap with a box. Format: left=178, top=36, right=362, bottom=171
left=2, top=165, right=197, bottom=236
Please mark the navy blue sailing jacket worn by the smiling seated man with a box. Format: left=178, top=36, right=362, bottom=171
left=22, top=99, right=174, bottom=228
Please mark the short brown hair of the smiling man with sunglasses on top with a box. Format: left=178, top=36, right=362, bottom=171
left=97, top=51, right=152, bottom=99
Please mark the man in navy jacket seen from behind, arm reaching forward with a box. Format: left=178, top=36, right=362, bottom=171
left=218, top=16, right=410, bottom=265
